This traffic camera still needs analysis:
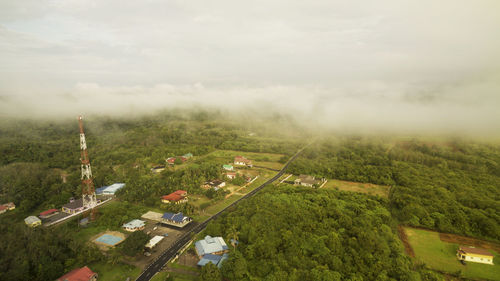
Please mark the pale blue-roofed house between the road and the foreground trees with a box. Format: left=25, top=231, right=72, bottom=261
left=194, top=235, right=229, bottom=267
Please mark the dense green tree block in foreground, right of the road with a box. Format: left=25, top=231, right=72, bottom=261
left=203, top=186, right=426, bottom=281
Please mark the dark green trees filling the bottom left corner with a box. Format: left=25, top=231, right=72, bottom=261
left=0, top=220, right=104, bottom=281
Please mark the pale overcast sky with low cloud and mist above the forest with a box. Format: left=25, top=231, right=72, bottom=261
left=0, top=0, right=500, bottom=134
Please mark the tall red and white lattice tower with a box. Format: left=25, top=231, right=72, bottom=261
left=78, top=116, right=97, bottom=220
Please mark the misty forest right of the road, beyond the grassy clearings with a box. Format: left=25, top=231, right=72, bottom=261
left=290, top=138, right=500, bottom=241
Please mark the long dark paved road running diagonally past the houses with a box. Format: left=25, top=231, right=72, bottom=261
left=136, top=145, right=304, bottom=281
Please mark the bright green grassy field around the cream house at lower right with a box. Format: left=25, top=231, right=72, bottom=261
left=405, top=228, right=500, bottom=280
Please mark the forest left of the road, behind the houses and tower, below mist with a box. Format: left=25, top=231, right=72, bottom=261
left=0, top=110, right=301, bottom=214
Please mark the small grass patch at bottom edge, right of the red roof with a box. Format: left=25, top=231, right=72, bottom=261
left=89, top=262, right=141, bottom=281
